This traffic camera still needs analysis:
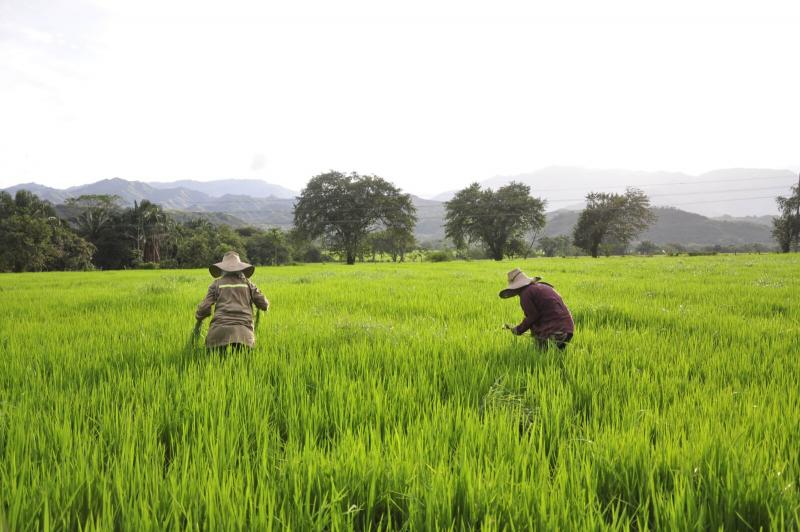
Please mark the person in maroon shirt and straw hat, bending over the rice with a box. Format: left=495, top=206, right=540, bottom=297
left=500, top=268, right=575, bottom=349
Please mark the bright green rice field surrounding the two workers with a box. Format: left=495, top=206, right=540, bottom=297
left=0, top=254, right=800, bottom=530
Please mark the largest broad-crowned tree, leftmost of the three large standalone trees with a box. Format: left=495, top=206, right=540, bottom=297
left=294, top=171, right=417, bottom=264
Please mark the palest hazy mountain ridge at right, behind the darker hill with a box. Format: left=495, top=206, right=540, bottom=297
left=434, top=166, right=797, bottom=217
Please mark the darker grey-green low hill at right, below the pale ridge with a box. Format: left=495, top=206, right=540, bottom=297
left=544, top=207, right=775, bottom=246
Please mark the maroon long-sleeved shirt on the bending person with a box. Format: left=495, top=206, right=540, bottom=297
left=514, top=283, right=575, bottom=338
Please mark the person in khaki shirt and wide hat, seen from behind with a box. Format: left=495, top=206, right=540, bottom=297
left=195, top=251, right=269, bottom=349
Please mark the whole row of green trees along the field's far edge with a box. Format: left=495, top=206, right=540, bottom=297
left=0, top=171, right=800, bottom=271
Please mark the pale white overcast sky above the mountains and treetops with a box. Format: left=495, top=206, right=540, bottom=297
left=0, top=0, right=800, bottom=195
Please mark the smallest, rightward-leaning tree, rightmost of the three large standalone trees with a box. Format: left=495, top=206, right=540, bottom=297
left=572, top=188, right=656, bottom=257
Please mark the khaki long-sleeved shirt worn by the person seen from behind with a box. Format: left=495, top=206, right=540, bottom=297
left=195, top=273, right=269, bottom=347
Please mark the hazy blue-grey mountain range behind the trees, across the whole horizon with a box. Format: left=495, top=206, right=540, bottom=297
left=5, top=167, right=797, bottom=245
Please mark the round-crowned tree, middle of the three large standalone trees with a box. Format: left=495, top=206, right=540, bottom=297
left=445, top=182, right=545, bottom=260
